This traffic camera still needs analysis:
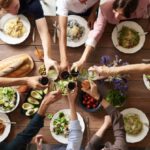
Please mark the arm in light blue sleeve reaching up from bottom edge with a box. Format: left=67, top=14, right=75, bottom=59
left=66, top=89, right=83, bottom=150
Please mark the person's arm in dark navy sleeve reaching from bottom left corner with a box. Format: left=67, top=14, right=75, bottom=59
left=0, top=91, right=61, bottom=150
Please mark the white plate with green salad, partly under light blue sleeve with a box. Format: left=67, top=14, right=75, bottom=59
left=50, top=109, right=85, bottom=144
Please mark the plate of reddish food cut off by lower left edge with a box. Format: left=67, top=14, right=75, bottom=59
left=0, top=113, right=11, bottom=142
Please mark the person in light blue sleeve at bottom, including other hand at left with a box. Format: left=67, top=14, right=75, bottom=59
left=32, top=88, right=83, bottom=150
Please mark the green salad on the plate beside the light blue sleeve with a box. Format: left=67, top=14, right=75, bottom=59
left=53, top=112, right=69, bottom=137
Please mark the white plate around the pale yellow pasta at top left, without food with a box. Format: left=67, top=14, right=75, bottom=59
left=0, top=14, right=31, bottom=45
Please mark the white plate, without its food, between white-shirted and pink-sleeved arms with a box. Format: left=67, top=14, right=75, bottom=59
left=67, top=15, right=90, bottom=47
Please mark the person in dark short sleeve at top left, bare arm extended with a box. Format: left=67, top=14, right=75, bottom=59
left=0, top=0, right=59, bottom=72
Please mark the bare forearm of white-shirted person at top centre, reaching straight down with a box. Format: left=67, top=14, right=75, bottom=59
left=58, top=16, right=68, bottom=70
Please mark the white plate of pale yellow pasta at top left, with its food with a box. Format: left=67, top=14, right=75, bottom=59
left=0, top=14, right=31, bottom=45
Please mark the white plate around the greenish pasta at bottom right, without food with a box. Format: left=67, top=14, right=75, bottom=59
left=121, top=108, right=149, bottom=143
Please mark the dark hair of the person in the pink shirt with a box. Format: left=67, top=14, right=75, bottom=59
left=113, top=0, right=139, bottom=18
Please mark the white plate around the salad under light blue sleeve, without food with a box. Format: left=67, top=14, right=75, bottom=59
left=50, top=109, right=85, bottom=144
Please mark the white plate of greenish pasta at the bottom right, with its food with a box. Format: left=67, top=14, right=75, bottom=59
left=121, top=108, right=149, bottom=143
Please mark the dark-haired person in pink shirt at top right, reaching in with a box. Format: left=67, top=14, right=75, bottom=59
left=71, top=0, right=150, bottom=69
